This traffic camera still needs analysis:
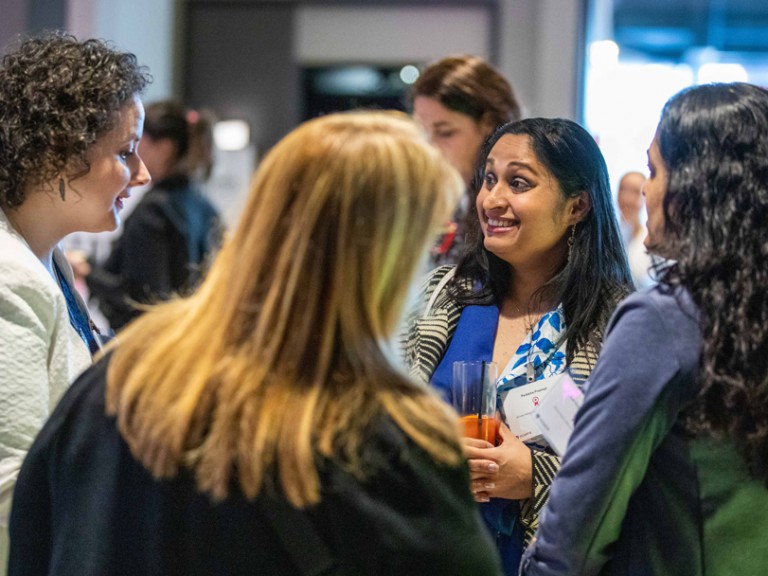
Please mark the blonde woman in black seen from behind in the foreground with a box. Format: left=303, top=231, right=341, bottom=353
left=10, top=112, right=500, bottom=576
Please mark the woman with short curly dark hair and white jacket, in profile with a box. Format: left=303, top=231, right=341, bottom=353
left=0, top=33, right=150, bottom=571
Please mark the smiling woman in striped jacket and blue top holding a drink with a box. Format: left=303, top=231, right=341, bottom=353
left=405, top=118, right=632, bottom=574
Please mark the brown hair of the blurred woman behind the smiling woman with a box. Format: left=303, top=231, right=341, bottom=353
left=411, top=56, right=520, bottom=127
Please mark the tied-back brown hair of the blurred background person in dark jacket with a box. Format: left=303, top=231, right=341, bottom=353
left=144, top=100, right=215, bottom=180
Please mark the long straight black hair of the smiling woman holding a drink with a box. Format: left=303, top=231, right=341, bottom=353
left=454, top=118, right=633, bottom=362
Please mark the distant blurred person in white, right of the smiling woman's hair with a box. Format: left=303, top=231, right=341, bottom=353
left=616, top=172, right=654, bottom=288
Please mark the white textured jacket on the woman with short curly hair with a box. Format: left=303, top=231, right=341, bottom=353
left=0, top=210, right=91, bottom=532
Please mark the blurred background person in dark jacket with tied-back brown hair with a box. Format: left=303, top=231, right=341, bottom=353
left=70, top=100, right=222, bottom=330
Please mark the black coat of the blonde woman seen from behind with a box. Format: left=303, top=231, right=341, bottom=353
left=9, top=359, right=501, bottom=576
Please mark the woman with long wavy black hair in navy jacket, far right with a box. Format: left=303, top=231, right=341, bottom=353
left=524, top=83, right=768, bottom=576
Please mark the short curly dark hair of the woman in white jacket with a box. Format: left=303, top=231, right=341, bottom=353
left=0, top=32, right=151, bottom=208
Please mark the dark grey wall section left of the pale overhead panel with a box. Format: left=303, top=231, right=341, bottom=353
left=182, top=1, right=300, bottom=158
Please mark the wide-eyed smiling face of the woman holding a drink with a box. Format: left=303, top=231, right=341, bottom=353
left=476, top=134, right=578, bottom=268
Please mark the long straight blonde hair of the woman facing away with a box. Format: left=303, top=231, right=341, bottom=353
left=107, top=112, right=464, bottom=507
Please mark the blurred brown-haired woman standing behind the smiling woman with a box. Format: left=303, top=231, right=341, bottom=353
left=412, top=56, right=521, bottom=266
